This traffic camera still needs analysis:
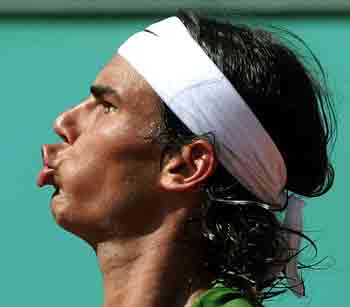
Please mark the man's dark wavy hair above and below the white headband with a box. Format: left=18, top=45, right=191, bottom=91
left=152, top=11, right=336, bottom=306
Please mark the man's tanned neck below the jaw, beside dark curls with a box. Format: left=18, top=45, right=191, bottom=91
left=96, top=207, right=210, bottom=307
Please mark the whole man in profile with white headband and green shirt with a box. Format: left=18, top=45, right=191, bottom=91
left=37, top=12, right=335, bottom=307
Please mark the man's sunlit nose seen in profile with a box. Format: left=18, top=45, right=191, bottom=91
left=53, top=106, right=79, bottom=144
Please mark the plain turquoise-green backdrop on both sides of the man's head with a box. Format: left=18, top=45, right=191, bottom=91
left=0, top=16, right=350, bottom=307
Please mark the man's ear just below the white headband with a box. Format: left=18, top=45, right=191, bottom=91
left=160, top=139, right=217, bottom=192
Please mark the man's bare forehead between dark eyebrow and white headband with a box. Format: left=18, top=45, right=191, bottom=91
left=94, top=54, right=160, bottom=116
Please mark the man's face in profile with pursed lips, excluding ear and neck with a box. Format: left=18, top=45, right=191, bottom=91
left=38, top=55, right=165, bottom=247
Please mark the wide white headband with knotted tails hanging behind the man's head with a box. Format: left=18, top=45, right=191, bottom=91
left=118, top=17, right=305, bottom=296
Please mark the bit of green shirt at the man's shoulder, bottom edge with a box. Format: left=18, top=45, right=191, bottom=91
left=192, top=283, right=252, bottom=307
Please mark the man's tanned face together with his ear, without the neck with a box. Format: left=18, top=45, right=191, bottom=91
left=40, top=55, right=216, bottom=243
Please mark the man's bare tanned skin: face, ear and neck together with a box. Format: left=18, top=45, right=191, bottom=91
left=48, top=55, right=217, bottom=307
